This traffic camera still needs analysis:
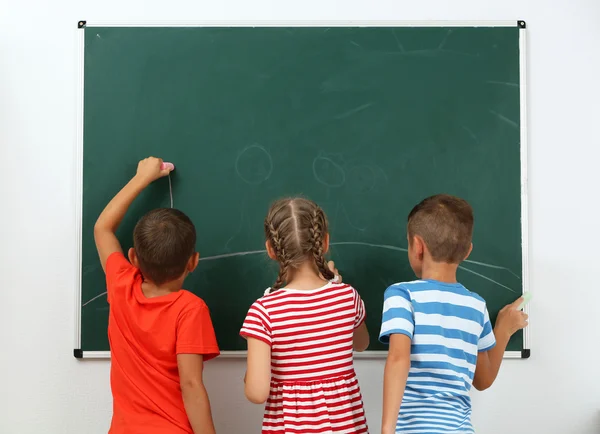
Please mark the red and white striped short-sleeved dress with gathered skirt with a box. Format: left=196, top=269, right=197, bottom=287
left=240, top=283, right=368, bottom=434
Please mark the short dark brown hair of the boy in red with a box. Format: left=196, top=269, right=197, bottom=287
left=133, top=208, right=196, bottom=285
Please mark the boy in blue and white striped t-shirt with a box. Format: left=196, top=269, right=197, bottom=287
left=380, top=195, right=527, bottom=434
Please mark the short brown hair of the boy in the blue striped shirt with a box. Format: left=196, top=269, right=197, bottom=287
left=407, top=194, right=473, bottom=264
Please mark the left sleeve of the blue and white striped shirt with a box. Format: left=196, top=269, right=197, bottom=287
left=379, top=285, right=415, bottom=344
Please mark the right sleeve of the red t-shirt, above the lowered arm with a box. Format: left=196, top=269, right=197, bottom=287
left=175, top=302, right=219, bottom=361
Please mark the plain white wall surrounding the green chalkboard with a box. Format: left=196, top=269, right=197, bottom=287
left=0, top=0, right=600, bottom=434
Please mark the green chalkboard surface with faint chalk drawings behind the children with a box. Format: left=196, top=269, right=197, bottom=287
left=80, top=25, right=524, bottom=352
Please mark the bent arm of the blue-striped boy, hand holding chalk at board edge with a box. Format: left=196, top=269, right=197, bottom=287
left=473, top=298, right=528, bottom=390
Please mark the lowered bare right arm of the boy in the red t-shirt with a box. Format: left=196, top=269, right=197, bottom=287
left=177, top=354, right=215, bottom=434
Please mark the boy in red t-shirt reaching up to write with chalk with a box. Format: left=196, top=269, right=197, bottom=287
left=94, top=157, right=219, bottom=434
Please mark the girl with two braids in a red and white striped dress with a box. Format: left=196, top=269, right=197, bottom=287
left=240, top=198, right=369, bottom=434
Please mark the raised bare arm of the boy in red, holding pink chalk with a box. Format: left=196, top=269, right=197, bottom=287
left=94, top=157, right=170, bottom=271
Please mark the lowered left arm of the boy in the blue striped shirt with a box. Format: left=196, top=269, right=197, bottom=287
left=381, top=334, right=411, bottom=434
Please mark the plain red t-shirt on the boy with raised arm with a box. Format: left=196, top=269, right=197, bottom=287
left=106, top=253, right=219, bottom=434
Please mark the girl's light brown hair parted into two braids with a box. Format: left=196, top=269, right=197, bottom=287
left=265, top=198, right=335, bottom=290
